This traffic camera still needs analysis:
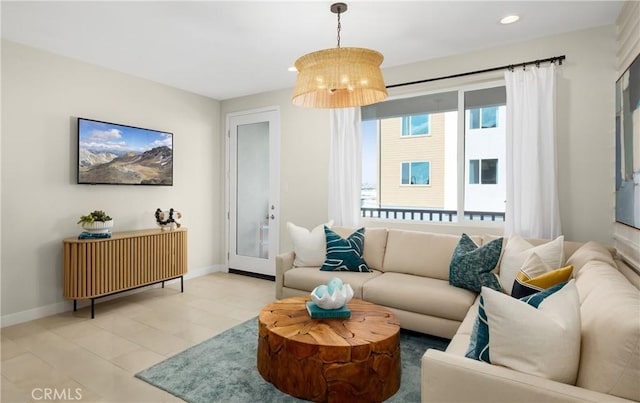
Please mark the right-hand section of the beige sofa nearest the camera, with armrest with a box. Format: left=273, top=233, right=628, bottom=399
left=422, top=242, right=640, bottom=403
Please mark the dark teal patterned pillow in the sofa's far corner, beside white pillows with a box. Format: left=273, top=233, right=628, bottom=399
left=449, top=234, right=502, bottom=292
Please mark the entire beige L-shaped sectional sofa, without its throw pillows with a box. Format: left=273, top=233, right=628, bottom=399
left=276, top=227, right=640, bottom=402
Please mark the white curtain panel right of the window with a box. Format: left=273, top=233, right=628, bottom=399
left=505, top=64, right=561, bottom=239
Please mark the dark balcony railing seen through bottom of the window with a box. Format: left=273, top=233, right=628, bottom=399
left=360, top=207, right=504, bottom=222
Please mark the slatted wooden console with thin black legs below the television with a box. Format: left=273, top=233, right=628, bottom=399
left=62, top=228, right=187, bottom=319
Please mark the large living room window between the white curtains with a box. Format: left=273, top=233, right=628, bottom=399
left=361, top=83, right=506, bottom=222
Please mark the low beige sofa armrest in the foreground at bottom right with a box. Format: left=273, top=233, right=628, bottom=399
left=421, top=349, right=630, bottom=403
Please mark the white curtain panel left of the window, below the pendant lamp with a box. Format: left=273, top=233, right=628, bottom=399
left=329, top=108, right=362, bottom=227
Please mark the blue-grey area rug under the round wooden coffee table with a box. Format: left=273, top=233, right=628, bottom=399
left=136, top=318, right=449, bottom=403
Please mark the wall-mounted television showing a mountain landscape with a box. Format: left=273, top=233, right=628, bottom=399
left=78, top=118, right=173, bottom=186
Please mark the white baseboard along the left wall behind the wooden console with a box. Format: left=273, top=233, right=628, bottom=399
left=0, top=265, right=228, bottom=328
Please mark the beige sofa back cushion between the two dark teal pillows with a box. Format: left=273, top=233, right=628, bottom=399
left=383, top=229, right=481, bottom=280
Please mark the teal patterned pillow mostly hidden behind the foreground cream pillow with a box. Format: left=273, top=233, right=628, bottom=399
left=465, top=282, right=567, bottom=364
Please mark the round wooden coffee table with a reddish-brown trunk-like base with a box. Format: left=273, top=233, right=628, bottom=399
left=258, top=297, right=400, bottom=402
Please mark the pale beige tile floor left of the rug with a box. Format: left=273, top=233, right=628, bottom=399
left=0, top=273, right=275, bottom=403
